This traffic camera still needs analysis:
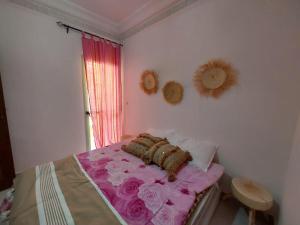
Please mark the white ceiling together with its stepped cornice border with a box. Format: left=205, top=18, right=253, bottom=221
left=8, top=0, right=197, bottom=41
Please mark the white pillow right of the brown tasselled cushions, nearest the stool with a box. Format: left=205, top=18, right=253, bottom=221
left=179, top=139, right=217, bottom=172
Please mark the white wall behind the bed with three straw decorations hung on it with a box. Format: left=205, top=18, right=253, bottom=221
left=125, top=0, right=300, bottom=200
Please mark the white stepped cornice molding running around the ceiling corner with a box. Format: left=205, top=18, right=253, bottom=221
left=8, top=0, right=198, bottom=42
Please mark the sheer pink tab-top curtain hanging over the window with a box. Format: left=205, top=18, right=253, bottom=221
left=82, top=34, right=122, bottom=148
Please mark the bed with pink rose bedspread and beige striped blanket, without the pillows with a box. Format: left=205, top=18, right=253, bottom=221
left=9, top=140, right=224, bottom=225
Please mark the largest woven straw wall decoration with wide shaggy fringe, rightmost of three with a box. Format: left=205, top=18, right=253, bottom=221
left=194, top=59, right=237, bottom=98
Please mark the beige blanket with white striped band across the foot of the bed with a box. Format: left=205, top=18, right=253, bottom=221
left=10, top=157, right=123, bottom=225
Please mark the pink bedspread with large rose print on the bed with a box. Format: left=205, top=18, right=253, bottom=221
left=77, top=143, right=224, bottom=225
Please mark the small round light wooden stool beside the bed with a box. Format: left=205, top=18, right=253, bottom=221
left=231, top=178, right=273, bottom=225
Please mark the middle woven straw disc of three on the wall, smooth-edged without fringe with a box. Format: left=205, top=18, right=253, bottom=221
left=163, top=81, right=183, bottom=105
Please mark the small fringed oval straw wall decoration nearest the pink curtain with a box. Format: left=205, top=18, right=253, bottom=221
left=140, top=70, right=158, bottom=95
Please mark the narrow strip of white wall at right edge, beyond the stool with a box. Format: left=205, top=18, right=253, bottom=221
left=280, top=116, right=300, bottom=225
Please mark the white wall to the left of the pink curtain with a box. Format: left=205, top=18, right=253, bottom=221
left=0, top=1, right=86, bottom=172
